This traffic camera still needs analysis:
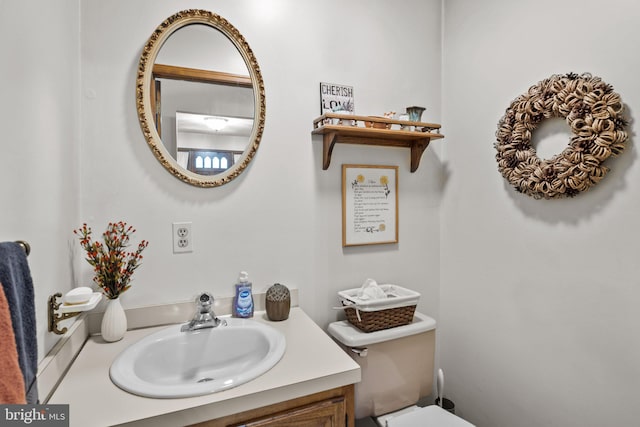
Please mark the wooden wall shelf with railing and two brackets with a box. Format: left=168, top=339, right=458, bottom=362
left=311, top=113, right=444, bottom=172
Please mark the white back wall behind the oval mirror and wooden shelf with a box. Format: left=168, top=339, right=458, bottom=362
left=75, top=0, right=441, bottom=348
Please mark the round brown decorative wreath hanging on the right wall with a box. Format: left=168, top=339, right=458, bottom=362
left=495, top=73, right=627, bottom=199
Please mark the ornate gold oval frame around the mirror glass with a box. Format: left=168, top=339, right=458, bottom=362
left=136, top=9, right=266, bottom=187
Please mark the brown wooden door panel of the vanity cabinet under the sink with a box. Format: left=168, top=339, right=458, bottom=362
left=237, top=397, right=346, bottom=427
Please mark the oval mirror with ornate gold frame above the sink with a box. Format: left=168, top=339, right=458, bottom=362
left=136, top=9, right=265, bottom=187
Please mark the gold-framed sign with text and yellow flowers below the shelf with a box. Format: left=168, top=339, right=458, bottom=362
left=342, top=165, right=398, bottom=246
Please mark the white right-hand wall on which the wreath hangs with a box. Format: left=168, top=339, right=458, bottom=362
left=439, top=0, right=640, bottom=427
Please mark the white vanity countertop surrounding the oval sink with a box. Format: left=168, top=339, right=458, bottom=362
left=48, top=307, right=360, bottom=427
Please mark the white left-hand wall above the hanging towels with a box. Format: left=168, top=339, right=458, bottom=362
left=0, top=0, right=80, bottom=358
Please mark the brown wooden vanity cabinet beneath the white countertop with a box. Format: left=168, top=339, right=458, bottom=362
left=190, top=384, right=355, bottom=427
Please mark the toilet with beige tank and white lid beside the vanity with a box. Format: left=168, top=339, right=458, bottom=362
left=328, top=312, right=473, bottom=427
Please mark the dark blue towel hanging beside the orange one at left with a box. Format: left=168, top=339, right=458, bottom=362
left=0, top=242, right=38, bottom=404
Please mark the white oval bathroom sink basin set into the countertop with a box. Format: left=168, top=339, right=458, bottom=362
left=109, top=318, right=286, bottom=398
